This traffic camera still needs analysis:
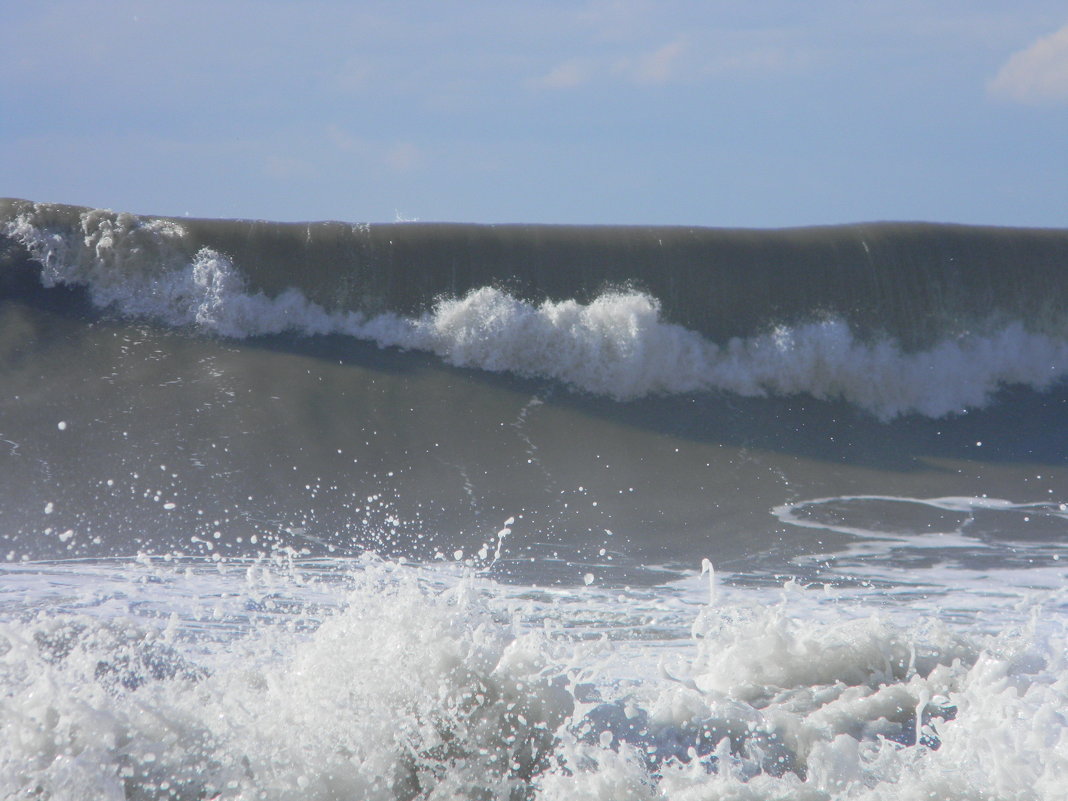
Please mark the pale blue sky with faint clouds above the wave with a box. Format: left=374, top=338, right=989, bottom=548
left=6, top=0, right=1068, bottom=227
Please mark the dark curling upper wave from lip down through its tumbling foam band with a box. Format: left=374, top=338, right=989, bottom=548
left=6, top=201, right=1068, bottom=420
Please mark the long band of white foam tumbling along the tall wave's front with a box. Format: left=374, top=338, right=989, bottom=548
left=5, top=205, right=1068, bottom=420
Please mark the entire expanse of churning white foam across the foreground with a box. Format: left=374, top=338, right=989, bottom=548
left=0, top=559, right=1068, bottom=801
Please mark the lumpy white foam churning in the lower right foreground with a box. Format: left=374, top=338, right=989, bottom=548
left=543, top=597, right=1068, bottom=801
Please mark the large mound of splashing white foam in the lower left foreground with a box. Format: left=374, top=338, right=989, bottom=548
left=0, top=568, right=571, bottom=800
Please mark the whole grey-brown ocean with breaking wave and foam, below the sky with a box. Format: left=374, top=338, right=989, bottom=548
left=0, top=200, right=1068, bottom=801
